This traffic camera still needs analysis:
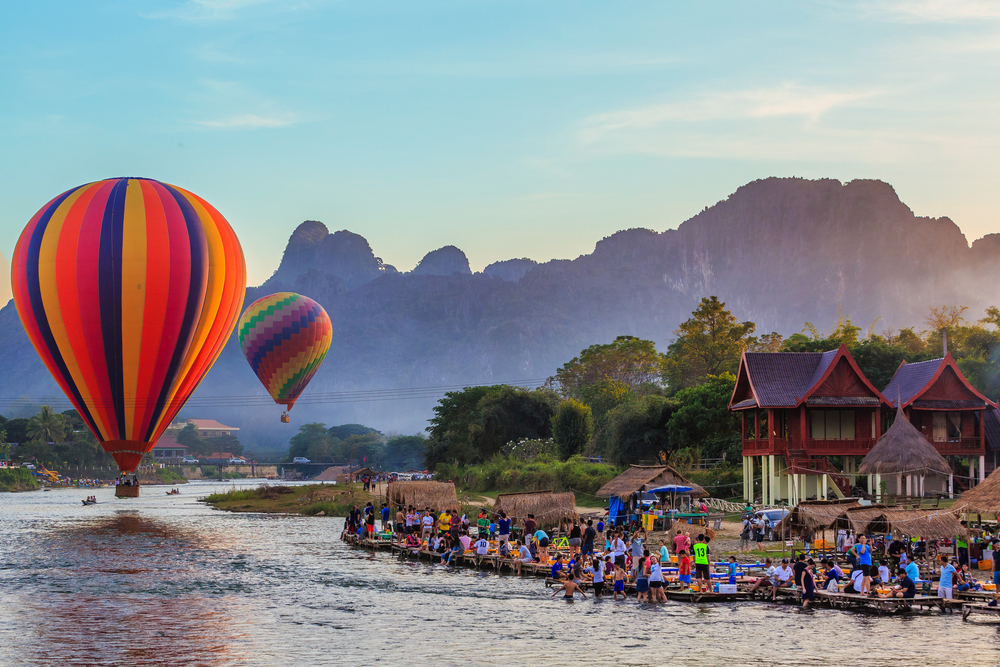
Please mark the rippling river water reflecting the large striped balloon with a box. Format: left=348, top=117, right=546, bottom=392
left=0, top=481, right=1000, bottom=667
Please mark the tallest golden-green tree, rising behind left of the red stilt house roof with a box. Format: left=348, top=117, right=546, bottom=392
left=663, top=296, right=757, bottom=392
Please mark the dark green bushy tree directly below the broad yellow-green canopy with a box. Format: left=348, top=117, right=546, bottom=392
left=606, top=395, right=676, bottom=465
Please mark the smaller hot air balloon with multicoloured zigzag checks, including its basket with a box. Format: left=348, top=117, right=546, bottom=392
left=237, top=292, right=333, bottom=422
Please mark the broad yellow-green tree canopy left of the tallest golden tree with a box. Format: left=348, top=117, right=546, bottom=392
left=550, top=336, right=663, bottom=398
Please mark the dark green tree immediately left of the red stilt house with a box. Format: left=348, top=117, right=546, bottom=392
left=667, top=373, right=742, bottom=458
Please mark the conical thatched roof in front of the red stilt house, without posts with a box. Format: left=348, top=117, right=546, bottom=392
left=858, top=408, right=951, bottom=477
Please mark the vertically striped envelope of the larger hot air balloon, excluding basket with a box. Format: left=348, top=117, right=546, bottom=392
left=11, top=178, right=246, bottom=472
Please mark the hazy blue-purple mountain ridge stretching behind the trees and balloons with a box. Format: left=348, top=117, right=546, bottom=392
left=0, top=178, right=1000, bottom=447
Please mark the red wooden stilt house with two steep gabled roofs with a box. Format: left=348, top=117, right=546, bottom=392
left=729, top=346, right=1000, bottom=505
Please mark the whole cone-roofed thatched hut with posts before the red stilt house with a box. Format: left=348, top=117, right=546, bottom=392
left=858, top=401, right=954, bottom=497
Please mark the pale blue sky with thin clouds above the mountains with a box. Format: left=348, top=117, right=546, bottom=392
left=0, top=0, right=1000, bottom=291
